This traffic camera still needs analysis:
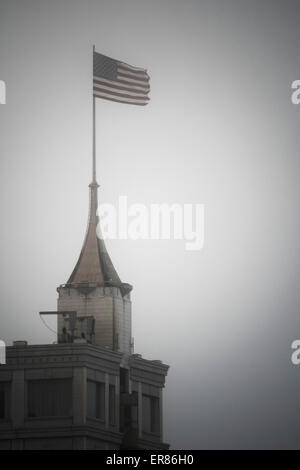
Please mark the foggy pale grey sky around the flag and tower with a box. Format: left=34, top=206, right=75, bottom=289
left=0, top=0, right=300, bottom=449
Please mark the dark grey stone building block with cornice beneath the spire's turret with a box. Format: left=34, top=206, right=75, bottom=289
left=0, top=342, right=168, bottom=450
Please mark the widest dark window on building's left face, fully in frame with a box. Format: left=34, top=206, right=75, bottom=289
left=28, top=379, right=72, bottom=418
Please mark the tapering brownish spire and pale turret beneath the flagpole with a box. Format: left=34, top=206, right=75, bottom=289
left=57, top=176, right=133, bottom=348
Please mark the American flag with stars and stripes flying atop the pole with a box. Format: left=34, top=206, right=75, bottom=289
left=93, top=52, right=150, bottom=106
